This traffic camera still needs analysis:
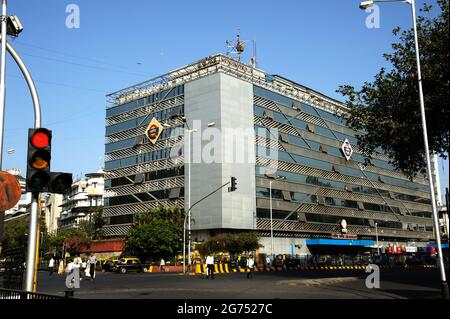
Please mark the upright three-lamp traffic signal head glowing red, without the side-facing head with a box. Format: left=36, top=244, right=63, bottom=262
left=26, top=128, right=52, bottom=192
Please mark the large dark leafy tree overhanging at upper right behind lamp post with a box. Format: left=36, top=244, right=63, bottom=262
left=337, top=0, right=449, bottom=179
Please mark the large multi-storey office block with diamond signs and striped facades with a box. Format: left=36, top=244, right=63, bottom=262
left=104, top=55, right=434, bottom=254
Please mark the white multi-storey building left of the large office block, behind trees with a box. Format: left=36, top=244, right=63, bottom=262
left=58, top=170, right=104, bottom=229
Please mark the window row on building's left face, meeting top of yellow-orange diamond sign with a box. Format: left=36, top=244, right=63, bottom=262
left=105, top=105, right=184, bottom=136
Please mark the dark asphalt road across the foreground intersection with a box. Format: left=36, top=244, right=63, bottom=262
left=33, top=269, right=440, bottom=299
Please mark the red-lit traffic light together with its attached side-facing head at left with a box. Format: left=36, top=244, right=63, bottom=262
left=26, top=128, right=72, bottom=194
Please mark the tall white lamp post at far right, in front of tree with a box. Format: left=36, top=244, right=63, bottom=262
left=359, top=0, right=449, bottom=299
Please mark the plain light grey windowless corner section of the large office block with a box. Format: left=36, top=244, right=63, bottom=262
left=185, top=73, right=256, bottom=230
